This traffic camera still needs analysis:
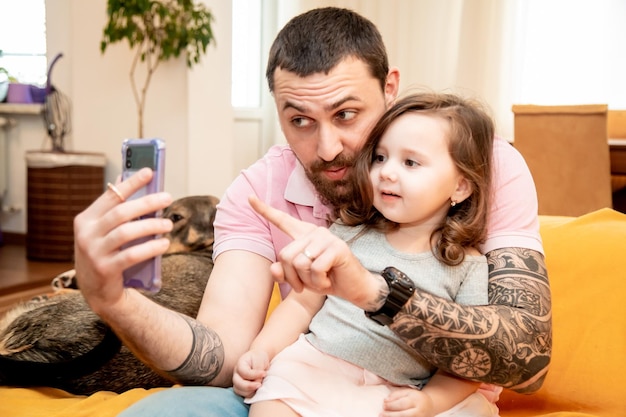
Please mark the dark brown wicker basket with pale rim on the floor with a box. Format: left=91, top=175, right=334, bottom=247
left=26, top=152, right=106, bottom=261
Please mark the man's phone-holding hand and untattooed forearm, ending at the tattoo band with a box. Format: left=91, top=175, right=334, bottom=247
left=74, top=169, right=206, bottom=382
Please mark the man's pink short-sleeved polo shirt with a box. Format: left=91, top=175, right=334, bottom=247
left=213, top=138, right=543, bottom=276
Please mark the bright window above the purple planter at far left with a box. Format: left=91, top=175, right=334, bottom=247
left=0, top=0, right=47, bottom=85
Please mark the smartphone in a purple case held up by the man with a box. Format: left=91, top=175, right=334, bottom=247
left=122, top=139, right=165, bottom=293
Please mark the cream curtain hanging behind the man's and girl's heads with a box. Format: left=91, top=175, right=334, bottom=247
left=278, top=0, right=516, bottom=137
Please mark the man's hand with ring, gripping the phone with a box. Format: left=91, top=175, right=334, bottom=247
left=74, top=164, right=172, bottom=319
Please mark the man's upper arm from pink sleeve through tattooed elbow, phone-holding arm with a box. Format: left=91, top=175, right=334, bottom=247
left=158, top=250, right=273, bottom=386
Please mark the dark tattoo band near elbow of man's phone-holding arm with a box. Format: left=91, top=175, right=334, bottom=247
left=167, top=316, right=224, bottom=385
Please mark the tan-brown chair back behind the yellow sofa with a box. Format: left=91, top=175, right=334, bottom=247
left=513, top=104, right=613, bottom=216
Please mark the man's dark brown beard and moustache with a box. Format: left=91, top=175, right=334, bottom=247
left=305, top=154, right=354, bottom=207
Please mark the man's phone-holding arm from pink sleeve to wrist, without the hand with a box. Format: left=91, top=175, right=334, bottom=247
left=96, top=250, right=273, bottom=387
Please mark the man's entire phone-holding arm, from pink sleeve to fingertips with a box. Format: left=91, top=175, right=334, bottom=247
left=74, top=169, right=273, bottom=386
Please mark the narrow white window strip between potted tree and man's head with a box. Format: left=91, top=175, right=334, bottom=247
left=231, top=0, right=263, bottom=108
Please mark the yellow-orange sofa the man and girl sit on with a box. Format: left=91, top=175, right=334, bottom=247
left=0, top=209, right=626, bottom=417
